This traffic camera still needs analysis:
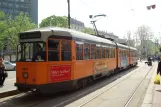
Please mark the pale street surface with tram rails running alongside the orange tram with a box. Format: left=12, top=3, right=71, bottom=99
left=0, top=62, right=157, bottom=107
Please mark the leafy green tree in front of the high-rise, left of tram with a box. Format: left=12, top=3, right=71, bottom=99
left=0, top=13, right=36, bottom=50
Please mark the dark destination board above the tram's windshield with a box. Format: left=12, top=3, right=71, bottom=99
left=19, top=32, right=41, bottom=39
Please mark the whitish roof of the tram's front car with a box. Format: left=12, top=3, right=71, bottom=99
left=20, top=27, right=115, bottom=45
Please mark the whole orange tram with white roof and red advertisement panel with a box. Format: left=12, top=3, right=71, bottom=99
left=15, top=27, right=138, bottom=93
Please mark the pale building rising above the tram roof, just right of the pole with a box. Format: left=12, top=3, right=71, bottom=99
left=70, top=18, right=85, bottom=31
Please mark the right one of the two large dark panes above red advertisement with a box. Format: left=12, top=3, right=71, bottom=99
left=61, top=40, right=71, bottom=61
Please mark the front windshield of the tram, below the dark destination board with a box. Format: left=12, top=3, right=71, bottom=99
left=17, top=42, right=46, bottom=62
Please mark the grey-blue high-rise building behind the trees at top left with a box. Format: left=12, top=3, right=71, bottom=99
left=0, top=0, right=38, bottom=24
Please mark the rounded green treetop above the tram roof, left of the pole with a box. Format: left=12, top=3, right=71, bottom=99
left=39, top=15, right=68, bottom=28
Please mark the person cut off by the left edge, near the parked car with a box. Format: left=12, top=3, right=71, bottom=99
left=0, top=54, right=6, bottom=86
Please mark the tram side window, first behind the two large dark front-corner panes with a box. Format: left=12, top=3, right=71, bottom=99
left=76, top=43, right=83, bottom=60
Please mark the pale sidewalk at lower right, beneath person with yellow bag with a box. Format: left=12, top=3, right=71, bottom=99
left=141, top=61, right=161, bottom=107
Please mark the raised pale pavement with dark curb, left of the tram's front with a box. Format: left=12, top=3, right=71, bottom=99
left=0, top=78, right=19, bottom=98
